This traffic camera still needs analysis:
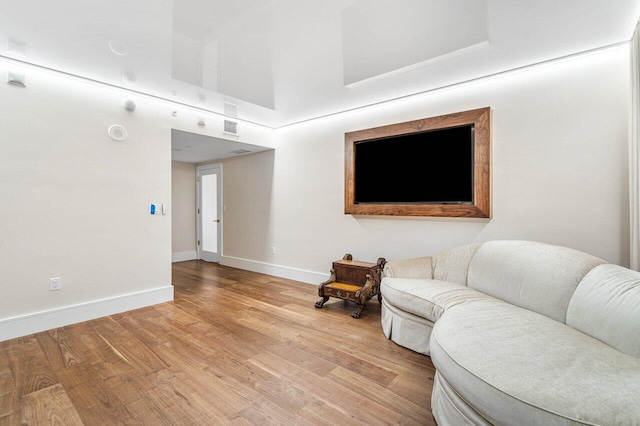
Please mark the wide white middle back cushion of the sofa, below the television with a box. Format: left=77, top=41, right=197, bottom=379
left=467, top=241, right=605, bottom=323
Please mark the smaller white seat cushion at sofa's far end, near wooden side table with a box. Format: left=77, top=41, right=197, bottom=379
left=380, top=277, right=494, bottom=322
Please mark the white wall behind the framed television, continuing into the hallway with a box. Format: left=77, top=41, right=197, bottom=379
left=223, top=46, right=630, bottom=282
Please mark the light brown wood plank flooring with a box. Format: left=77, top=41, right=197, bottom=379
left=0, top=261, right=435, bottom=426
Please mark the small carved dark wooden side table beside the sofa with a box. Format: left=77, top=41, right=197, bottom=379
left=315, top=254, right=385, bottom=318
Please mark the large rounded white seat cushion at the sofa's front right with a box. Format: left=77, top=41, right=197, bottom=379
left=430, top=300, right=640, bottom=425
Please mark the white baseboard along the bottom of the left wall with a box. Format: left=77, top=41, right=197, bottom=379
left=0, top=285, right=173, bottom=342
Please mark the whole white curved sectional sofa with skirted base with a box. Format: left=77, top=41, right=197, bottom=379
left=380, top=241, right=640, bottom=425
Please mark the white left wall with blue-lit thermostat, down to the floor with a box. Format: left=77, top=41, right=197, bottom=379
left=0, top=63, right=173, bottom=340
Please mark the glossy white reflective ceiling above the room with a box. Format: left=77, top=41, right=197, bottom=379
left=0, top=0, right=640, bottom=127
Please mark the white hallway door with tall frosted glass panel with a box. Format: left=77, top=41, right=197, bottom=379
left=196, top=164, right=222, bottom=262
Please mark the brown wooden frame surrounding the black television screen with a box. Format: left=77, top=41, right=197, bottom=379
left=344, top=107, right=491, bottom=218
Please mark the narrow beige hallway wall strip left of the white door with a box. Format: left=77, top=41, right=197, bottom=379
left=171, top=161, right=197, bottom=262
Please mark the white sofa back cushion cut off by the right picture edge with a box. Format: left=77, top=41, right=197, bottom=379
left=567, top=264, right=640, bottom=358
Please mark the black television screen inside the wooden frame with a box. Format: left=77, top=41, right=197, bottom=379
left=354, top=125, right=474, bottom=204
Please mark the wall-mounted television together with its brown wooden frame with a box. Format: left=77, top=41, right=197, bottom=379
left=345, top=108, right=491, bottom=218
